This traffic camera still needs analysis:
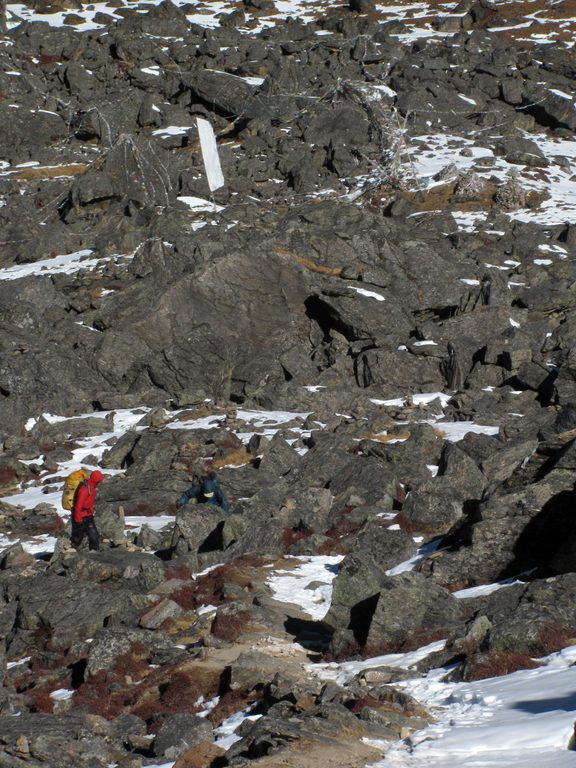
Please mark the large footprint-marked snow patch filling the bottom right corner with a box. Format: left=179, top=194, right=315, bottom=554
left=373, top=646, right=576, bottom=768
